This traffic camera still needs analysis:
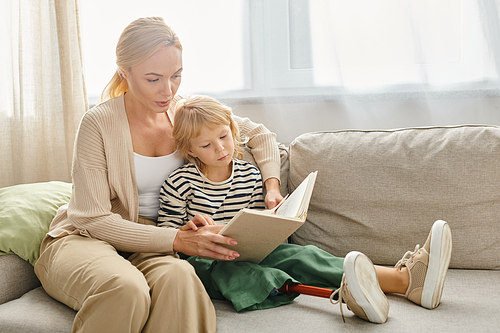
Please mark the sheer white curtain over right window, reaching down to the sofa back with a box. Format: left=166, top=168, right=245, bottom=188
left=230, top=0, right=500, bottom=143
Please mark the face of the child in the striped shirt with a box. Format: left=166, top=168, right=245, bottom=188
left=188, top=125, right=234, bottom=172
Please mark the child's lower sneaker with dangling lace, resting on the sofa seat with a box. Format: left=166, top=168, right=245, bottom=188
left=330, top=251, right=389, bottom=324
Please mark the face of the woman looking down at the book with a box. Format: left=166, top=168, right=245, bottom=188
left=122, top=46, right=182, bottom=113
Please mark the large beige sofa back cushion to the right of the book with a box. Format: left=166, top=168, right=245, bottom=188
left=289, top=125, right=500, bottom=269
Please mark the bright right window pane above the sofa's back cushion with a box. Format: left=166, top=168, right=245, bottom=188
left=270, top=0, right=498, bottom=90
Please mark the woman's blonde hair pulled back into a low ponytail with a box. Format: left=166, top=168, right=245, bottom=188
left=101, top=17, right=182, bottom=101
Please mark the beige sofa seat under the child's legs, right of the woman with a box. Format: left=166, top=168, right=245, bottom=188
left=214, top=270, right=500, bottom=333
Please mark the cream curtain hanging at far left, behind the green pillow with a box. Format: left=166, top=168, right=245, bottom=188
left=0, top=0, right=87, bottom=187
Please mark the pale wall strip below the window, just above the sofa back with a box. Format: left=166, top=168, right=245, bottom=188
left=231, top=96, right=500, bottom=144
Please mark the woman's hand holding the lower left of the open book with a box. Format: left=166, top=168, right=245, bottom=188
left=174, top=225, right=240, bottom=260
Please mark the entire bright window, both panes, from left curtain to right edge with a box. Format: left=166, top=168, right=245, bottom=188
left=81, top=0, right=500, bottom=103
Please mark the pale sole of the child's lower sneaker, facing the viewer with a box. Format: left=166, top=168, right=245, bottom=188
left=344, top=251, right=389, bottom=324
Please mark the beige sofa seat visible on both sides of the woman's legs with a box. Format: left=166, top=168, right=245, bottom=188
left=0, top=270, right=500, bottom=333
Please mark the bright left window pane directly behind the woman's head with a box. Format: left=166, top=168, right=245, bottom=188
left=80, top=0, right=250, bottom=104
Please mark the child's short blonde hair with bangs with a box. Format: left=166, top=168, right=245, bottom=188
left=173, top=95, right=243, bottom=171
